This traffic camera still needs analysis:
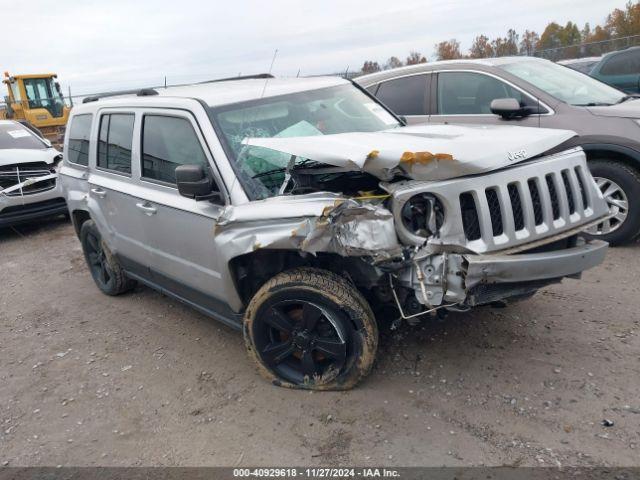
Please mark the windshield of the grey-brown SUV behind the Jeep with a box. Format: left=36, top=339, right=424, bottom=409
left=500, top=60, right=624, bottom=106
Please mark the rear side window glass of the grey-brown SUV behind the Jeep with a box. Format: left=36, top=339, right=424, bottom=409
left=376, top=75, right=427, bottom=115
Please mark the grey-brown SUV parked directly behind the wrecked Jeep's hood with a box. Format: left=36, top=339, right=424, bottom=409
left=355, top=57, right=640, bottom=245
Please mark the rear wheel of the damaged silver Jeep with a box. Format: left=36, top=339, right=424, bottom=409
left=80, top=220, right=136, bottom=295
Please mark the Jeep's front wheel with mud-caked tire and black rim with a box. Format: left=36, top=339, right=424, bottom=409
left=244, top=268, right=378, bottom=390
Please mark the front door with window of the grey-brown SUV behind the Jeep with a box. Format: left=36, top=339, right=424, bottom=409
left=430, top=71, right=539, bottom=127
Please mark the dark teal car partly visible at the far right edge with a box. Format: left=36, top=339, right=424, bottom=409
left=589, top=47, right=640, bottom=94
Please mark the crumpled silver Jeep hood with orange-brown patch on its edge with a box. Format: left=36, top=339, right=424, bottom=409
left=243, top=125, right=576, bottom=180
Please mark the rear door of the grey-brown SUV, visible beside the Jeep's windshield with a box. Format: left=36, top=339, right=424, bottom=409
left=368, top=73, right=431, bottom=125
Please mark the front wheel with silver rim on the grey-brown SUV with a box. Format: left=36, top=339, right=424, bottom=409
left=586, top=160, right=640, bottom=245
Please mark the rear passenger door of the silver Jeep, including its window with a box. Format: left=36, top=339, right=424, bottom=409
left=89, top=109, right=150, bottom=277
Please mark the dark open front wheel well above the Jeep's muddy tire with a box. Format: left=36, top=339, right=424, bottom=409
left=229, top=249, right=382, bottom=305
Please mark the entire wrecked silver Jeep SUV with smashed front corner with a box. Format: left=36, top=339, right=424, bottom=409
left=60, top=75, right=610, bottom=389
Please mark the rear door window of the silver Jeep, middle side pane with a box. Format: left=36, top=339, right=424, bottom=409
left=98, top=113, right=135, bottom=174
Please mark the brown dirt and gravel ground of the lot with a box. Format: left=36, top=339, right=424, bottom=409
left=0, top=221, right=640, bottom=466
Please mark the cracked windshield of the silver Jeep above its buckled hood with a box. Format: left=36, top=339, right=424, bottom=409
left=212, top=85, right=400, bottom=200
